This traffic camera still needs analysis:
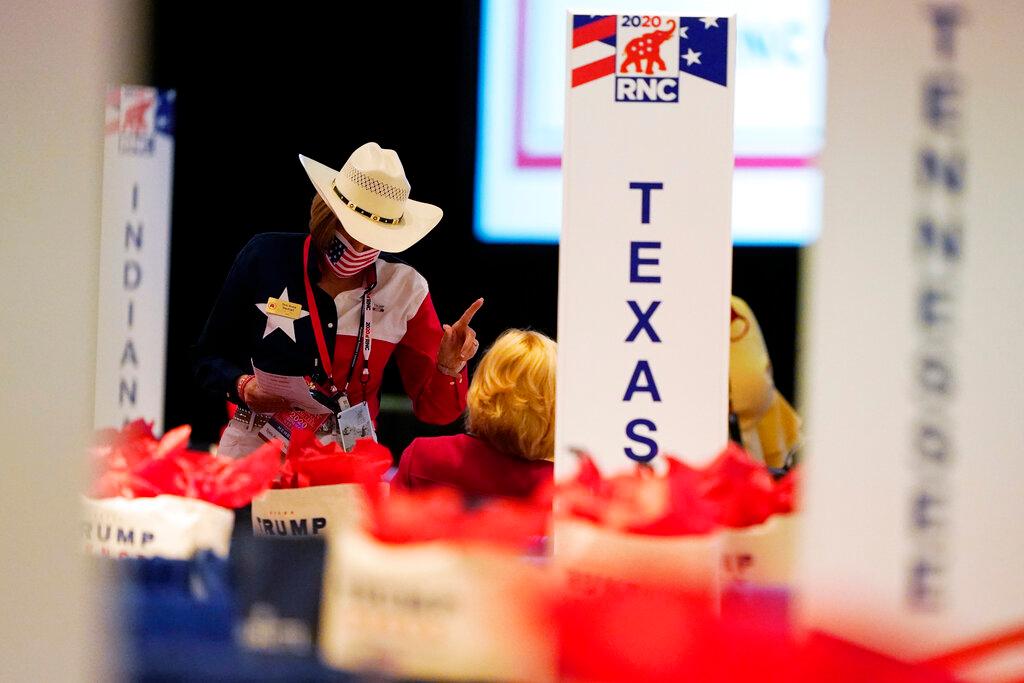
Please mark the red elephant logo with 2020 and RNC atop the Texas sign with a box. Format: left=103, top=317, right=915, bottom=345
left=615, top=14, right=679, bottom=102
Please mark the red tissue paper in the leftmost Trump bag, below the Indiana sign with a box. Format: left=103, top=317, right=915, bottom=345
left=89, top=420, right=281, bottom=508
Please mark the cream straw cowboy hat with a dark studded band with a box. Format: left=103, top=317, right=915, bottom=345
left=299, top=142, right=443, bottom=253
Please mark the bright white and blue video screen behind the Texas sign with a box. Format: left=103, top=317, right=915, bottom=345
left=474, top=0, right=827, bottom=246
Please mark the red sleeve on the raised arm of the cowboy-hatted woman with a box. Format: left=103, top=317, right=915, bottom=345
left=394, top=294, right=469, bottom=425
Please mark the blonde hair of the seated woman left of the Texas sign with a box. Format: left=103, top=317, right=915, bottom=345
left=466, top=330, right=556, bottom=460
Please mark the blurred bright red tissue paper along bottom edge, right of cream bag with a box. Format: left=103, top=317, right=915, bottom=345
left=556, top=587, right=957, bottom=683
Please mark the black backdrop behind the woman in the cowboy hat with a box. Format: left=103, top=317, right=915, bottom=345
left=153, top=0, right=799, bottom=449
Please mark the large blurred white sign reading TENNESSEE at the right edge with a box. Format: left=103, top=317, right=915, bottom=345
left=800, top=0, right=1024, bottom=680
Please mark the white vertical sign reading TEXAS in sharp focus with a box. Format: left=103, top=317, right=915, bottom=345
left=561, top=13, right=735, bottom=476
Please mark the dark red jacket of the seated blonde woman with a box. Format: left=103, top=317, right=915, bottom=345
left=391, top=434, right=554, bottom=498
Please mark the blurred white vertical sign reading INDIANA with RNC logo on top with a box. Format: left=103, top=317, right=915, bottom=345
left=95, top=86, right=174, bottom=434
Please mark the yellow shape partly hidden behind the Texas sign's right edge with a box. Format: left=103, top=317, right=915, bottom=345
left=729, top=296, right=800, bottom=467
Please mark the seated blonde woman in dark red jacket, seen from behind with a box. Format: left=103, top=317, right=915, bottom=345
left=392, top=330, right=556, bottom=498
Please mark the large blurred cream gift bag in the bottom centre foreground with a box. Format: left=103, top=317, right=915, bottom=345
left=319, top=527, right=556, bottom=683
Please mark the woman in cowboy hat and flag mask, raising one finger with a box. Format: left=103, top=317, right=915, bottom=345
left=194, top=142, right=483, bottom=457
